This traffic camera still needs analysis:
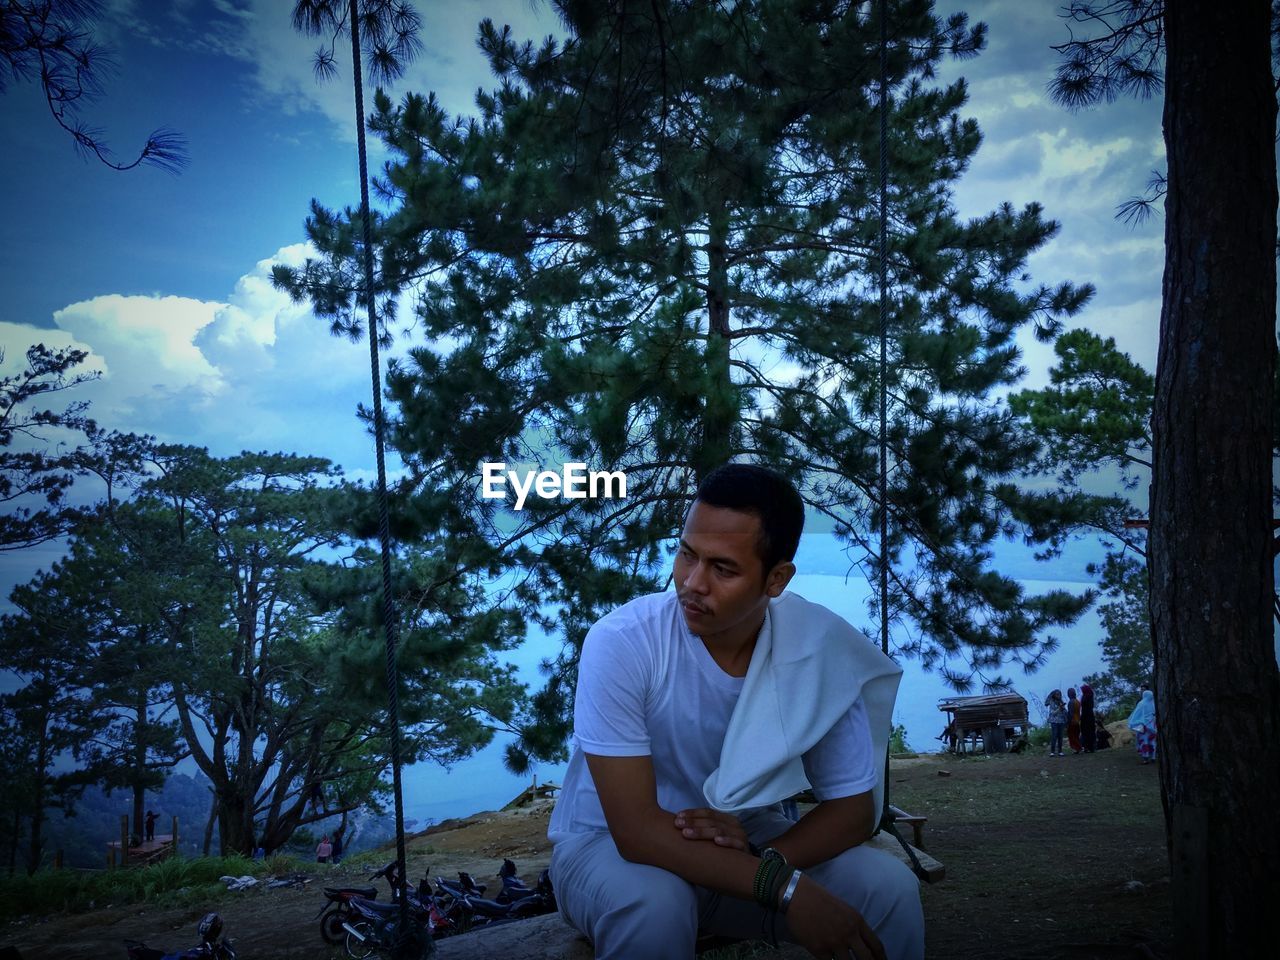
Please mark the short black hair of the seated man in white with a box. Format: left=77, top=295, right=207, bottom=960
left=698, top=463, right=804, bottom=573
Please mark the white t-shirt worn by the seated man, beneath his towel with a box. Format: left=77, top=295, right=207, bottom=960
left=548, top=591, right=878, bottom=842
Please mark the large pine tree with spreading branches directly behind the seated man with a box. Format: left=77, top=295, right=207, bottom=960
left=275, top=0, right=1092, bottom=765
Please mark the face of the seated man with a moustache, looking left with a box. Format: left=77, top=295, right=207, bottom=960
left=673, top=500, right=795, bottom=643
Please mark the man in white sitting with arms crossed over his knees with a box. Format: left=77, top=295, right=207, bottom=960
left=548, top=463, right=924, bottom=960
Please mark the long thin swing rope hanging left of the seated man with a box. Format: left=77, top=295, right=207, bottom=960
left=349, top=0, right=419, bottom=960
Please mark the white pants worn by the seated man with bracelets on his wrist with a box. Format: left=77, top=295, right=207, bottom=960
left=550, top=810, right=924, bottom=960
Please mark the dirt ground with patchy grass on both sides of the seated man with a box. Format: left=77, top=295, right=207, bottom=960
left=0, top=749, right=1170, bottom=960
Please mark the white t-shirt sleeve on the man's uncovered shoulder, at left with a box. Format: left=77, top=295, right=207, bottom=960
left=573, top=623, right=653, bottom=756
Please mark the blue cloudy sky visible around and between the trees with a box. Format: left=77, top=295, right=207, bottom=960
left=0, top=0, right=1164, bottom=824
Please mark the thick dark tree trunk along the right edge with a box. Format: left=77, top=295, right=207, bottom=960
left=1149, top=0, right=1280, bottom=957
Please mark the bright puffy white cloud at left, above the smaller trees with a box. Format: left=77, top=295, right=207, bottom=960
left=0, top=244, right=384, bottom=470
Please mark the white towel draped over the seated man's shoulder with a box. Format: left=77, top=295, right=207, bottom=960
left=703, top=593, right=902, bottom=815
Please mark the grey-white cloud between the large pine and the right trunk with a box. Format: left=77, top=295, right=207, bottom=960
left=938, top=0, right=1165, bottom=387
